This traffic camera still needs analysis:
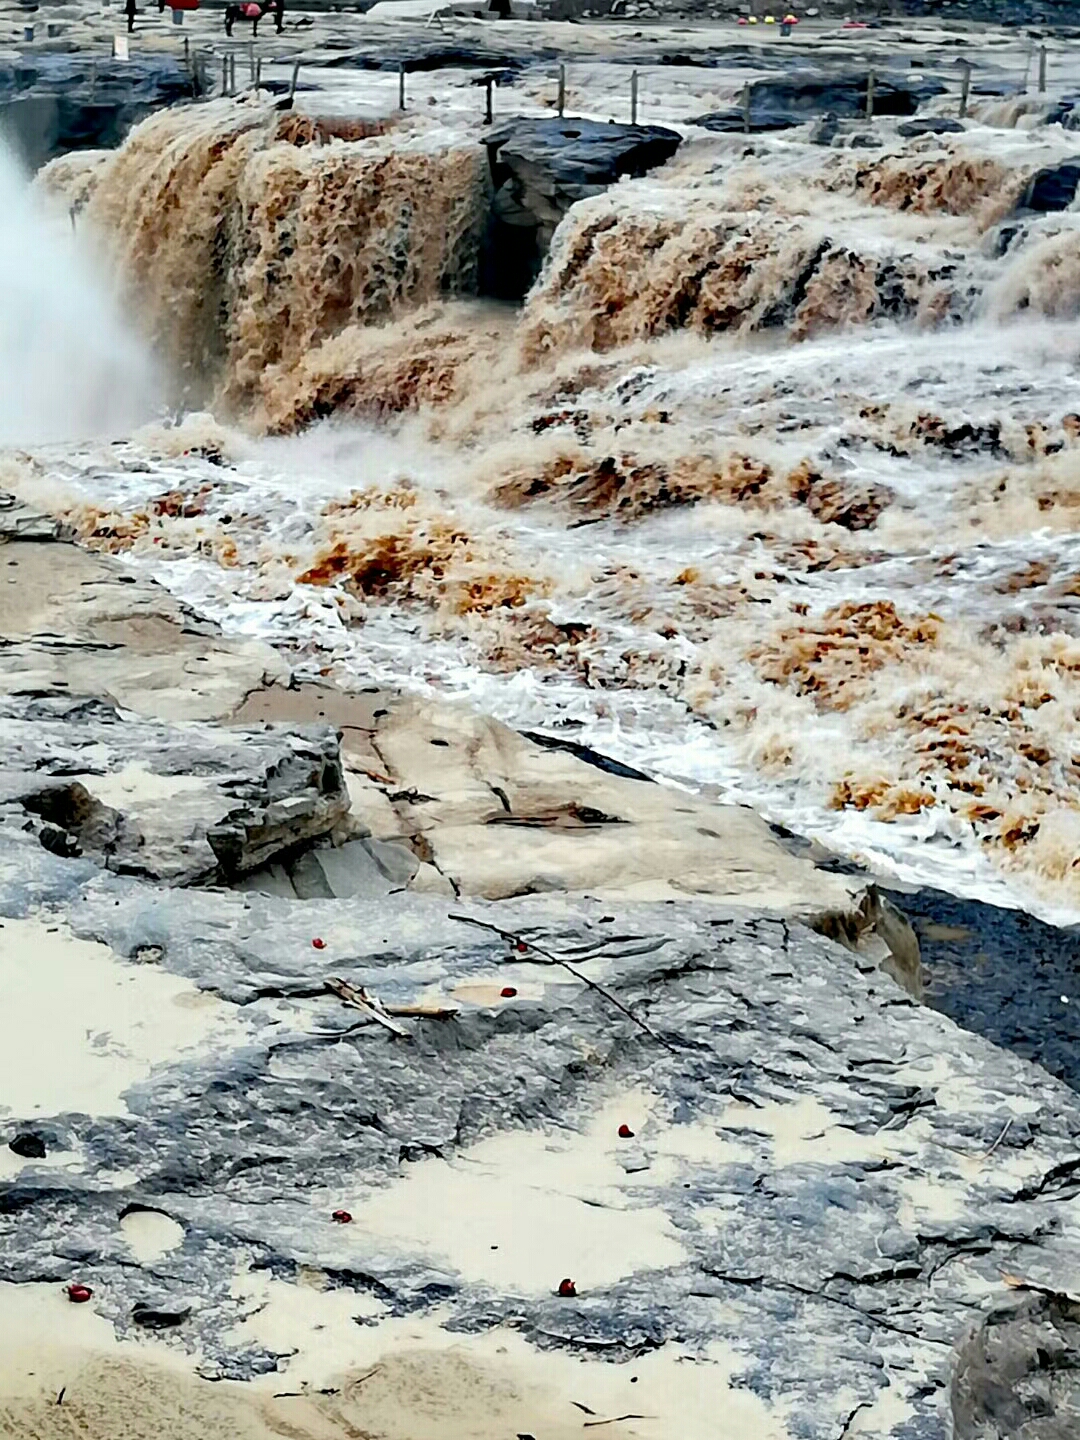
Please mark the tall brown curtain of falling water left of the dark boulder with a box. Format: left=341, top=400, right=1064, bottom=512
left=40, top=99, right=487, bottom=428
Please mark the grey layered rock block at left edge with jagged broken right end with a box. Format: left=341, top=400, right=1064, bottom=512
left=0, top=697, right=348, bottom=884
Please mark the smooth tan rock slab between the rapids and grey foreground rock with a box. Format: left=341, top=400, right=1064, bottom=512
left=238, top=687, right=922, bottom=995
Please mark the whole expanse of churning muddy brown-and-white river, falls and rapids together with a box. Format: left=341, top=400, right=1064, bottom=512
left=12, top=98, right=1080, bottom=920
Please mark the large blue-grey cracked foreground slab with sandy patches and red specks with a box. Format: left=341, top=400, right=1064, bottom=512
left=0, top=852, right=1080, bottom=1440
